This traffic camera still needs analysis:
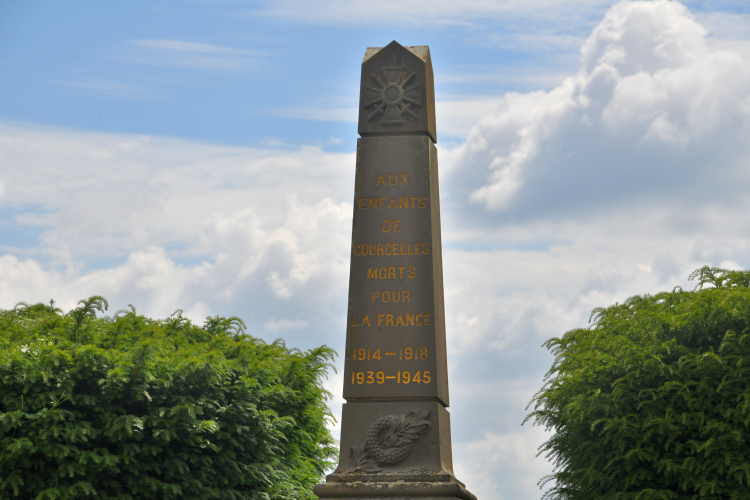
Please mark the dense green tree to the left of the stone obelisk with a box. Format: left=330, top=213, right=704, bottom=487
left=0, top=297, right=337, bottom=500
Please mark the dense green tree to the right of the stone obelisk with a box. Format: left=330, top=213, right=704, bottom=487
left=526, top=267, right=750, bottom=500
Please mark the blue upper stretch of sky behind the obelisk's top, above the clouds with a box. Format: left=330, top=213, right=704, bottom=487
left=0, top=1, right=607, bottom=151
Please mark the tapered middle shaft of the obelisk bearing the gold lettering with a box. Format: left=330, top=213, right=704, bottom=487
left=344, top=136, right=449, bottom=406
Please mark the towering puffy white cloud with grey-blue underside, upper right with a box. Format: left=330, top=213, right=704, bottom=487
left=452, top=0, right=750, bottom=217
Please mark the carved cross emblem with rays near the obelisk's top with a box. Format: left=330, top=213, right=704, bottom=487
left=365, top=66, right=421, bottom=125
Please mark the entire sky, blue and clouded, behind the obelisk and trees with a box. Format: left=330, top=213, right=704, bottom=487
left=0, top=0, right=750, bottom=499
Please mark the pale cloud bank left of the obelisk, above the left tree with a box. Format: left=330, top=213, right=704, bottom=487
left=0, top=125, right=354, bottom=352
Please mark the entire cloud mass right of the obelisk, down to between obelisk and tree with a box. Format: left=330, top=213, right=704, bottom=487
left=441, top=0, right=750, bottom=497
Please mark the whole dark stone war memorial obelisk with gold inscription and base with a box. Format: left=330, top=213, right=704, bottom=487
left=313, top=41, right=476, bottom=500
